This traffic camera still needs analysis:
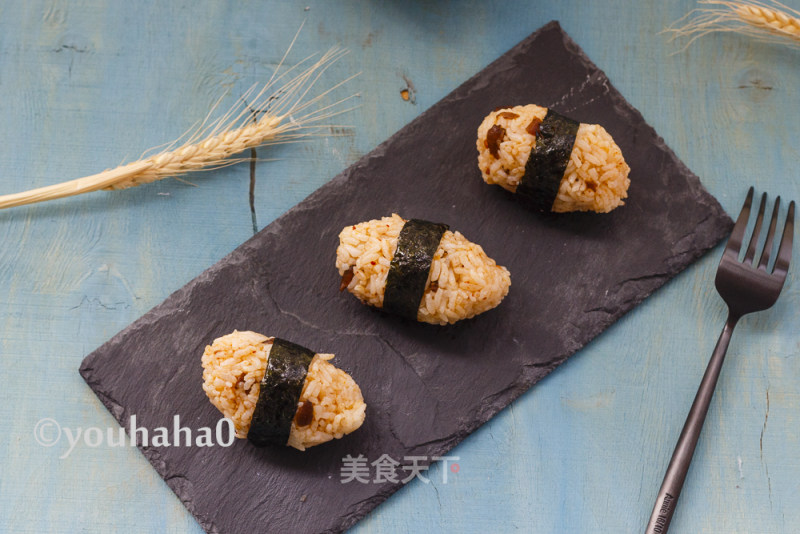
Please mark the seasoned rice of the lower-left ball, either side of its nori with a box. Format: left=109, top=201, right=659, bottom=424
left=202, top=330, right=366, bottom=451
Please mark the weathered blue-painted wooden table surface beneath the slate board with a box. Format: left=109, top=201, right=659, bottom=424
left=0, top=0, right=800, bottom=534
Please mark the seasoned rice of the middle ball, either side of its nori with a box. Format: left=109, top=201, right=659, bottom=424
left=336, top=214, right=511, bottom=325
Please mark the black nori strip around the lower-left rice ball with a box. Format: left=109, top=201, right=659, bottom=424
left=247, top=337, right=314, bottom=447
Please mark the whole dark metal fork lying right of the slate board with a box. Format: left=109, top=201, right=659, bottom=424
left=645, top=187, right=794, bottom=534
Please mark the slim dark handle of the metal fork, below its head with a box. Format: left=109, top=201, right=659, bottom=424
left=645, top=314, right=739, bottom=534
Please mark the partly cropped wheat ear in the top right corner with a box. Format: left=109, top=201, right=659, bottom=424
left=665, top=0, right=800, bottom=49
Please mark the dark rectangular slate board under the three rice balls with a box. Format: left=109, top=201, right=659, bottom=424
left=80, top=23, right=731, bottom=533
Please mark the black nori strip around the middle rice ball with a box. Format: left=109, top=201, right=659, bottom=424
left=383, top=219, right=449, bottom=321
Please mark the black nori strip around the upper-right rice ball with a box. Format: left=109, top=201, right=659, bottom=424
left=516, top=109, right=580, bottom=211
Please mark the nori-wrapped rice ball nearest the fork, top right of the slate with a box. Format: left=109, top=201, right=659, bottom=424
left=477, top=104, right=630, bottom=213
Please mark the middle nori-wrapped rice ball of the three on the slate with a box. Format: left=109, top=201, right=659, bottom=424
left=336, top=214, right=511, bottom=325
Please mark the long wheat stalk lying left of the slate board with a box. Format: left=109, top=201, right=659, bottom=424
left=0, top=34, right=358, bottom=213
